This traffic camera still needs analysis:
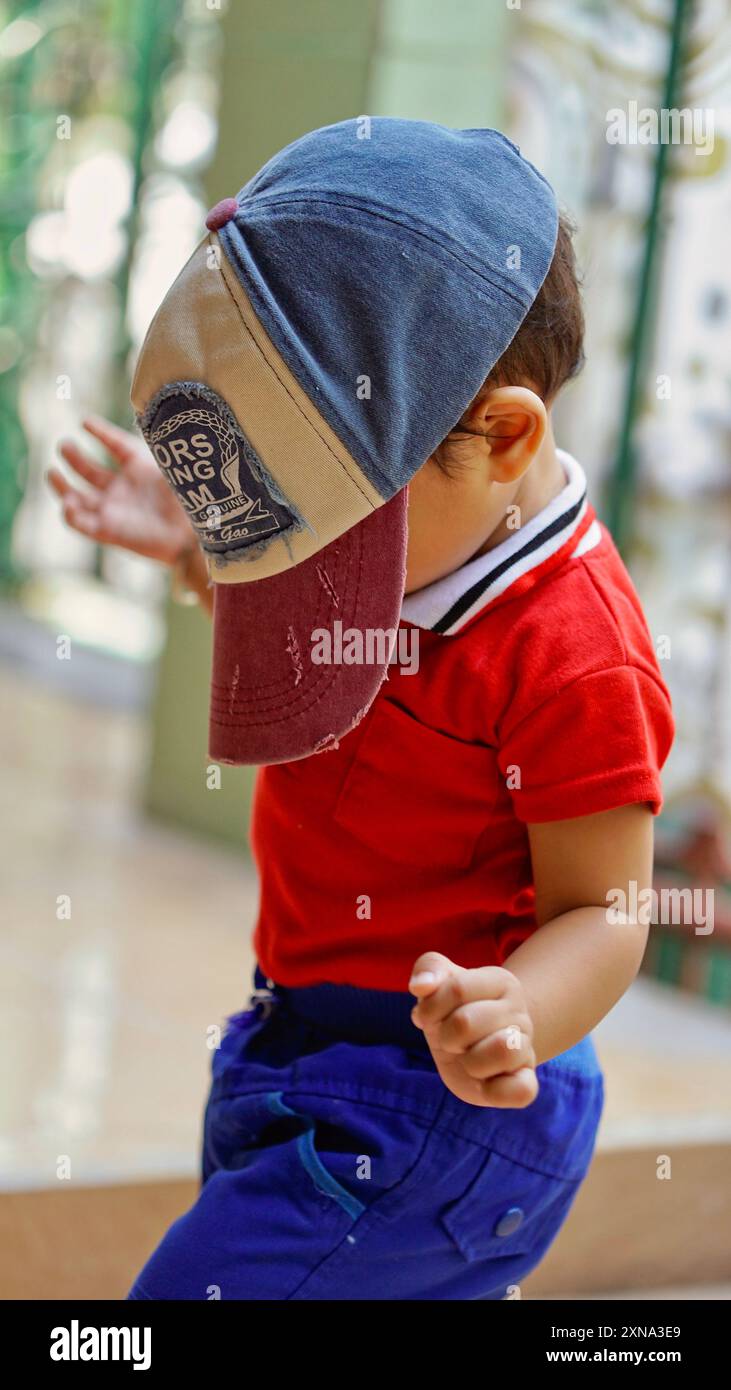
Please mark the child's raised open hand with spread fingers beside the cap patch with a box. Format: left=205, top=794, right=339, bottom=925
left=47, top=416, right=196, bottom=564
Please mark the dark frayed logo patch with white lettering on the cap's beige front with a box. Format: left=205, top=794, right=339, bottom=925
left=140, top=381, right=299, bottom=553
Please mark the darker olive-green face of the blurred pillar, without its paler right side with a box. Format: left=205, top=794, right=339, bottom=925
left=146, top=0, right=378, bottom=845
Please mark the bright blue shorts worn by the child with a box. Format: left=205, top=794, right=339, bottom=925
left=129, top=969, right=603, bottom=1301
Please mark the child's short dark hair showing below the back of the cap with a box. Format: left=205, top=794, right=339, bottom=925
left=434, top=213, right=584, bottom=473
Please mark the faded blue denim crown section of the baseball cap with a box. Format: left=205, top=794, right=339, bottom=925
left=220, top=117, right=557, bottom=498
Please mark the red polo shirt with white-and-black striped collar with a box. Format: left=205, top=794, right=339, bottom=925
left=252, top=453, right=673, bottom=991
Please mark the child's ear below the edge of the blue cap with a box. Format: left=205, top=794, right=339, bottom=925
left=464, top=386, right=548, bottom=482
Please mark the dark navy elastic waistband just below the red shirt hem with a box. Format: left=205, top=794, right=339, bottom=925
left=254, top=966, right=429, bottom=1052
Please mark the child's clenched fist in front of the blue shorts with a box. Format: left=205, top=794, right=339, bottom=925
left=409, top=951, right=538, bottom=1109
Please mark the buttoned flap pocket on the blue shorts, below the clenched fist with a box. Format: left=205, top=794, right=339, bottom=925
left=441, top=1152, right=581, bottom=1261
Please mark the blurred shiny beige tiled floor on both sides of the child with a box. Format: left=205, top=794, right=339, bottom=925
left=0, top=656, right=731, bottom=1188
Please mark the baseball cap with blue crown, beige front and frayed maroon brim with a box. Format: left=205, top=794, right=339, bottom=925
left=132, top=117, right=557, bottom=763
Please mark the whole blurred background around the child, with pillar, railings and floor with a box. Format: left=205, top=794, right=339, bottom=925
left=0, top=0, right=731, bottom=1298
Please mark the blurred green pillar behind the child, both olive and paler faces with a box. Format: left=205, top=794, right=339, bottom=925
left=146, top=0, right=510, bottom=844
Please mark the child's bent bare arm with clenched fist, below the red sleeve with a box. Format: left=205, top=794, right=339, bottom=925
left=410, top=805, right=653, bottom=1106
